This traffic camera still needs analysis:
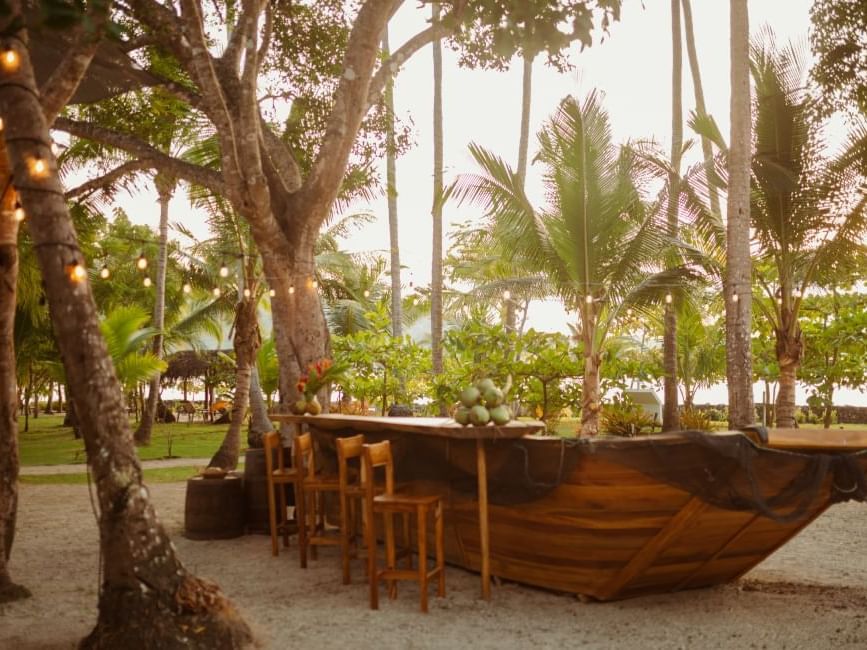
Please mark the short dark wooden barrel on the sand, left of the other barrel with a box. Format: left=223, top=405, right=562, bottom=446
left=184, top=474, right=244, bottom=539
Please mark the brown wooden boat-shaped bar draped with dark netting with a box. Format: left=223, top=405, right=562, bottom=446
left=272, top=416, right=867, bottom=600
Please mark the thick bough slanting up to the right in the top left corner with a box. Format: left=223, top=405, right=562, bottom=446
left=39, top=0, right=111, bottom=128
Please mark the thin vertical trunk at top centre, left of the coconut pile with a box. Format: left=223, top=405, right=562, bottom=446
left=431, top=2, right=446, bottom=415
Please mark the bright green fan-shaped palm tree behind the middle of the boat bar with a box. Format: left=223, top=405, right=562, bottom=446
left=456, top=93, right=690, bottom=435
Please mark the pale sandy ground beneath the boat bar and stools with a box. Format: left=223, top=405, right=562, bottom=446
left=0, top=483, right=867, bottom=650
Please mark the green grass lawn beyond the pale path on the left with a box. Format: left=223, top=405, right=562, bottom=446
left=18, top=415, right=228, bottom=465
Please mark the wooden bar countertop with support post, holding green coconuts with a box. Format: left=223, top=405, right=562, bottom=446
left=270, top=414, right=545, bottom=599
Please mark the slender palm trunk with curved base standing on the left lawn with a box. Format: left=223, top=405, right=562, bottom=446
left=135, top=174, right=175, bottom=446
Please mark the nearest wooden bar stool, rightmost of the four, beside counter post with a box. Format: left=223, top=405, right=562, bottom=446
left=361, top=440, right=446, bottom=613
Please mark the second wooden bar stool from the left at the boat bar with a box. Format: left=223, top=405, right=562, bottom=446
left=294, top=433, right=341, bottom=569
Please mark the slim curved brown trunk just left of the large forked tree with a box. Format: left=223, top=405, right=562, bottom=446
left=208, top=298, right=262, bottom=469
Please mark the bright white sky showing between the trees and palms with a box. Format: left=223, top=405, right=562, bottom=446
left=108, top=0, right=865, bottom=403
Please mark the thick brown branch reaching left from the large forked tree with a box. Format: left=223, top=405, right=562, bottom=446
left=54, top=117, right=226, bottom=195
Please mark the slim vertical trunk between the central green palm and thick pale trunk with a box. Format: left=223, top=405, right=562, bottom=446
left=662, top=0, right=683, bottom=431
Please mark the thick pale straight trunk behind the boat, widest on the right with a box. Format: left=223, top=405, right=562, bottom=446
left=724, top=0, right=756, bottom=429
